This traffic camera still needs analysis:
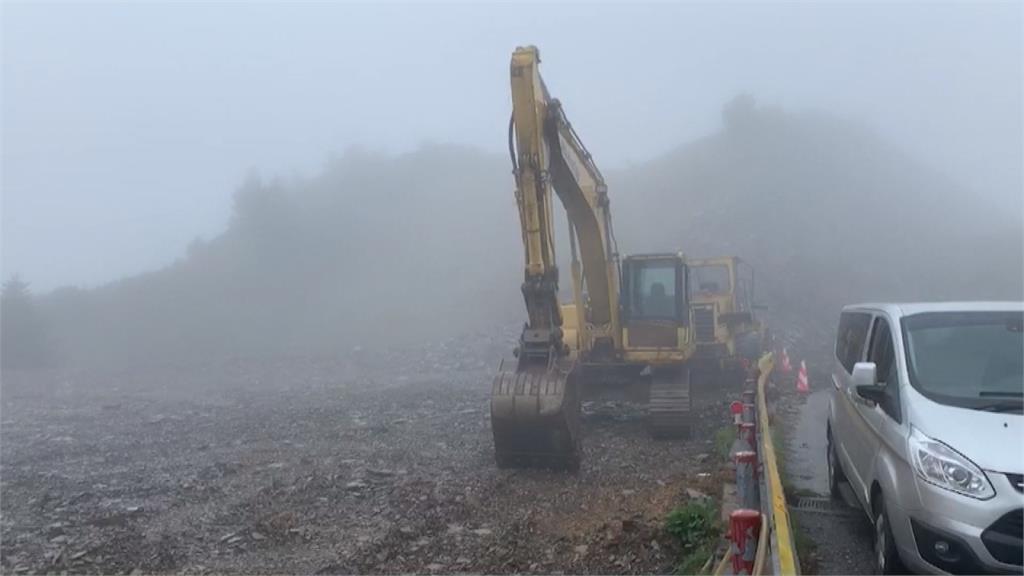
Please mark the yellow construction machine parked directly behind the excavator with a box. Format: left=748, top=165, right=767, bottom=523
left=687, top=256, right=767, bottom=383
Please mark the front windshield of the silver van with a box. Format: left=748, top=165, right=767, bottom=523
left=902, top=312, right=1024, bottom=412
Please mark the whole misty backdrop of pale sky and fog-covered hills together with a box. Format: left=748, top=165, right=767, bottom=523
left=2, top=3, right=1024, bottom=367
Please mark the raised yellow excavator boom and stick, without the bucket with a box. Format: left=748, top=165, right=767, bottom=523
left=509, top=46, right=621, bottom=357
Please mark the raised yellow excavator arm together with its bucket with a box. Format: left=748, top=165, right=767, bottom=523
left=490, top=46, right=622, bottom=468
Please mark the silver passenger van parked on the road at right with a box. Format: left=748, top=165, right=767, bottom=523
left=826, top=302, right=1024, bottom=574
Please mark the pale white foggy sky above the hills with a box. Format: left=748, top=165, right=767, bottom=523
left=2, top=2, right=1024, bottom=289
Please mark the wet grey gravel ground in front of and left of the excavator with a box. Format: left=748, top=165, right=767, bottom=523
left=0, top=340, right=728, bottom=573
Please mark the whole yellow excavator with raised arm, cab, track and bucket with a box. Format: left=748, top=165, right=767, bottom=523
left=490, top=46, right=696, bottom=469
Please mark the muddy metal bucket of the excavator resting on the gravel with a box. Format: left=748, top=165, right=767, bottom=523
left=490, top=360, right=582, bottom=470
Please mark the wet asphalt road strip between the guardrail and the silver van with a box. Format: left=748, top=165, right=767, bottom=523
left=779, top=388, right=873, bottom=574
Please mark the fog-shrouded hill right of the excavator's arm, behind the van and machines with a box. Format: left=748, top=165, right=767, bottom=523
left=612, top=98, right=1024, bottom=355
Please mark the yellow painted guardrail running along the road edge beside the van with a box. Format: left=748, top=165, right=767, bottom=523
left=754, top=353, right=800, bottom=576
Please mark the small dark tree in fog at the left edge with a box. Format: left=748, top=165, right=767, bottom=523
left=0, top=276, right=52, bottom=370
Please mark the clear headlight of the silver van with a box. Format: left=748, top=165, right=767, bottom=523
left=910, top=428, right=995, bottom=500
